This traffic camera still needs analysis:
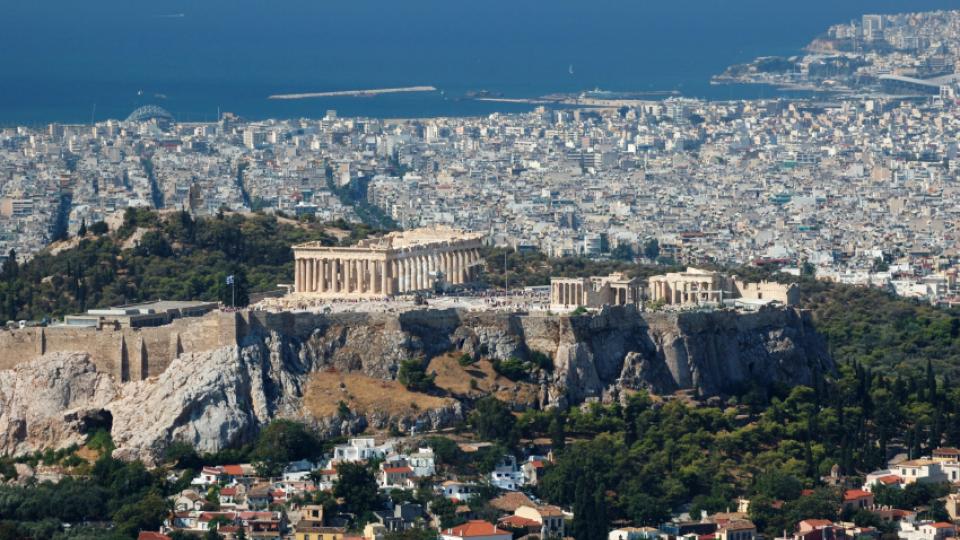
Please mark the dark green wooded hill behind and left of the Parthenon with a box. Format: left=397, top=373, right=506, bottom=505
left=0, top=209, right=382, bottom=320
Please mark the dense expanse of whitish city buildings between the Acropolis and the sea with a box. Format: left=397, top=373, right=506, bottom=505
left=0, top=12, right=960, bottom=304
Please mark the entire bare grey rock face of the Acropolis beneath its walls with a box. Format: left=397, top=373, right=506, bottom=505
left=0, top=308, right=833, bottom=461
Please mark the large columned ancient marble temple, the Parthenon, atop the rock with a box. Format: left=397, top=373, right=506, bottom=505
left=293, top=227, right=483, bottom=298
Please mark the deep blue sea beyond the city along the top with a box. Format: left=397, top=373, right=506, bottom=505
left=0, top=0, right=960, bottom=125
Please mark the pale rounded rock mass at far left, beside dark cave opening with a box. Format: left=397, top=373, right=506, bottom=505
left=0, top=353, right=117, bottom=454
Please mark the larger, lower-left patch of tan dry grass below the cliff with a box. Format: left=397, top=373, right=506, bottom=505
left=303, top=371, right=454, bottom=417
